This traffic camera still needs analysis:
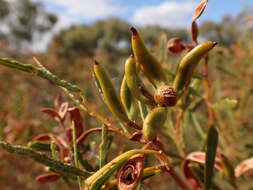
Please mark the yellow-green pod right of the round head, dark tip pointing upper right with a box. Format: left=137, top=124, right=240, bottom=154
left=173, top=41, right=217, bottom=92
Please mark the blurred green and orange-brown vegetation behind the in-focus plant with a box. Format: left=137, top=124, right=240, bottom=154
left=0, top=0, right=253, bottom=190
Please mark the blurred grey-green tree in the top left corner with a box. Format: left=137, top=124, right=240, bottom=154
left=0, top=0, right=57, bottom=53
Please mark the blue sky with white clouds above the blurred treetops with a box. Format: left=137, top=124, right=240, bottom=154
left=37, top=0, right=253, bottom=28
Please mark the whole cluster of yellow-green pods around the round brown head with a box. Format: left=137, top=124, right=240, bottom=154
left=93, top=27, right=216, bottom=140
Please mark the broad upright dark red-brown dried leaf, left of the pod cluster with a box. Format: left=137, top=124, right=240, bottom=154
left=68, top=107, right=83, bottom=138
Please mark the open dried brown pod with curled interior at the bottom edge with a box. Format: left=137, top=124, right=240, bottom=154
left=117, top=154, right=144, bottom=190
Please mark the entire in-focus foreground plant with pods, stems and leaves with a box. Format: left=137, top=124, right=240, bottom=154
left=0, top=0, right=250, bottom=190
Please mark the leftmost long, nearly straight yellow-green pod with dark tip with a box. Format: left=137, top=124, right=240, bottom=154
left=93, top=61, right=130, bottom=123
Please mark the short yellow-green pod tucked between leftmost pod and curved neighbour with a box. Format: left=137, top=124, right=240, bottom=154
left=120, top=76, right=136, bottom=118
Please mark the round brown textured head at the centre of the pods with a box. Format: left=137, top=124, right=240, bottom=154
left=154, top=86, right=178, bottom=107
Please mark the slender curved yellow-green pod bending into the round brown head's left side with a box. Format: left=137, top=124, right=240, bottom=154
left=125, top=56, right=154, bottom=105
